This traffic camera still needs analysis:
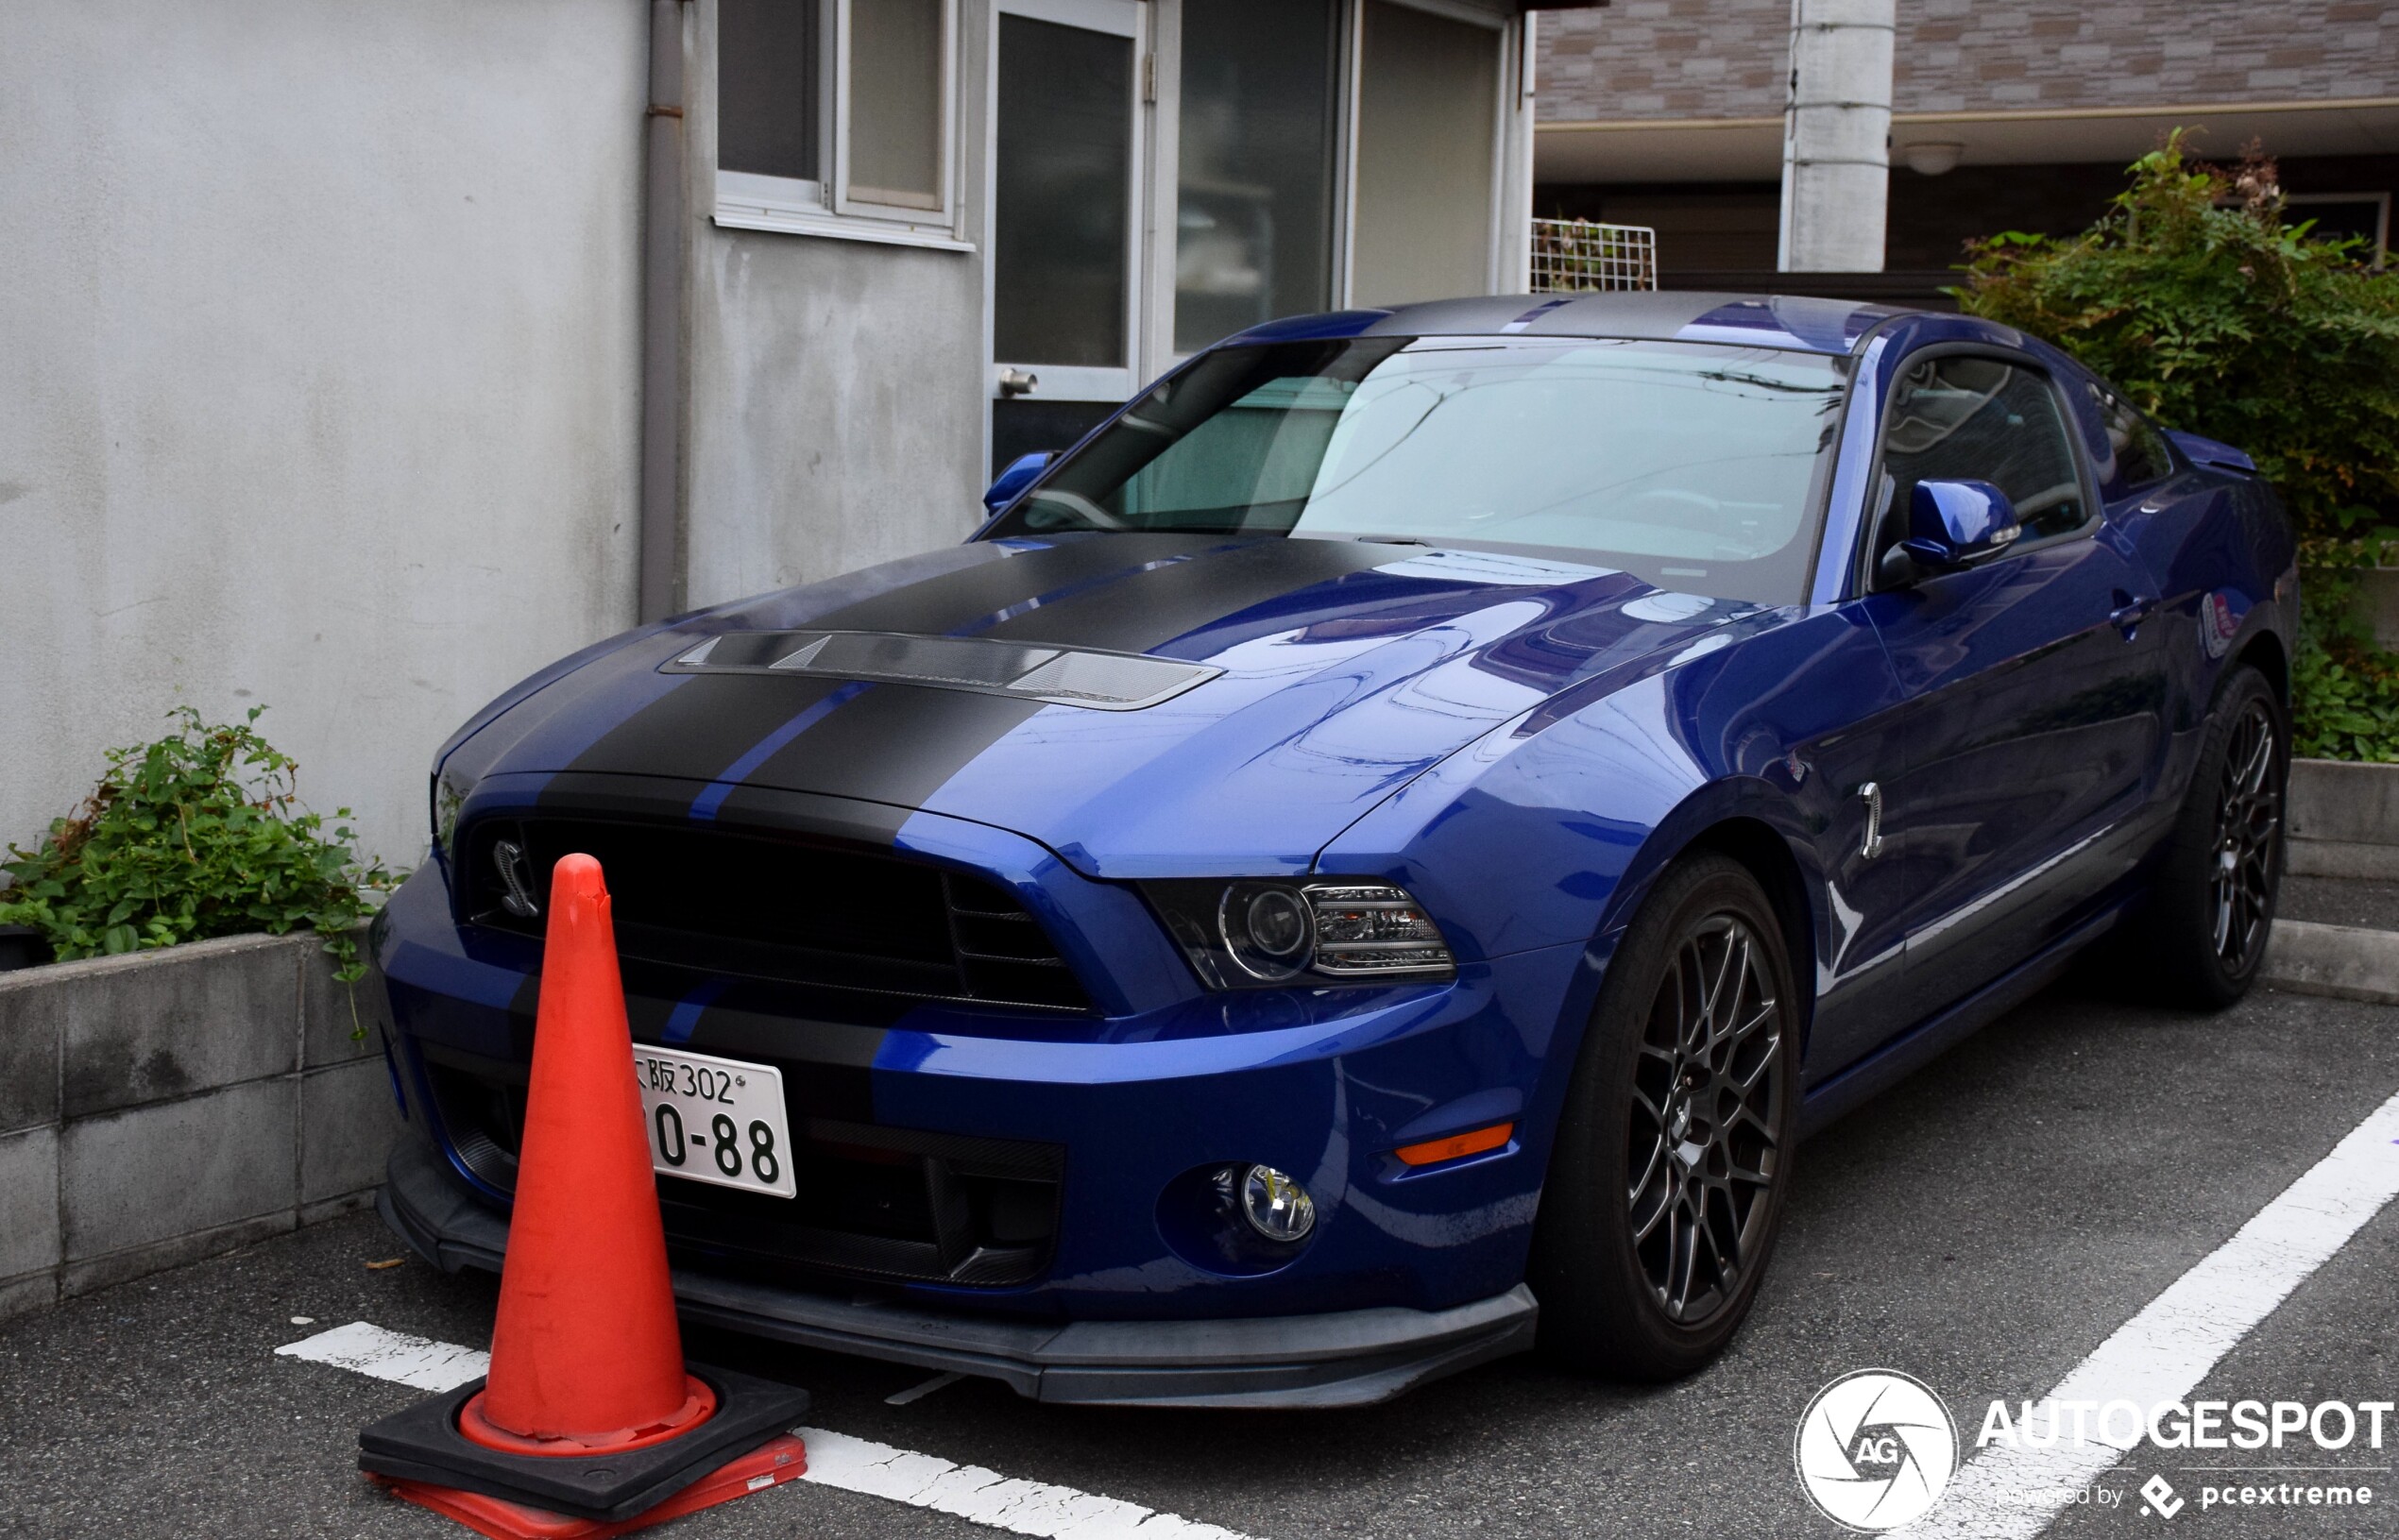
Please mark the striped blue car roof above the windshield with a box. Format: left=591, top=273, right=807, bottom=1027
left=1226, top=290, right=1931, bottom=355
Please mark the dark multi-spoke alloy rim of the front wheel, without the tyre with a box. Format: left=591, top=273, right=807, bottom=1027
left=1626, top=911, right=1787, bottom=1327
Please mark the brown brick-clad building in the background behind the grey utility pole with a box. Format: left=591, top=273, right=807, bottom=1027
left=1536, top=0, right=2399, bottom=285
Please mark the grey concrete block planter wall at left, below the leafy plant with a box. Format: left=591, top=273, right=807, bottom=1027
left=0, top=936, right=400, bottom=1319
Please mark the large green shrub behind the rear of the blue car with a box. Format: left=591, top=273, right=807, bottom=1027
left=1953, top=134, right=2399, bottom=542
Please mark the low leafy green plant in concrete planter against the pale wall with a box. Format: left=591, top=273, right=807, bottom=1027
left=0, top=705, right=394, bottom=1020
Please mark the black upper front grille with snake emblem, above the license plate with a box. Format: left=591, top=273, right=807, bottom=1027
left=456, top=818, right=1092, bottom=1012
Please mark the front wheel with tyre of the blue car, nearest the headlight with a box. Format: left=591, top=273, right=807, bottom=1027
left=1531, top=854, right=1799, bottom=1379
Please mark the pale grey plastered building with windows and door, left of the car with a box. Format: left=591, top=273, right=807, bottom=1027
left=0, top=0, right=1574, bottom=864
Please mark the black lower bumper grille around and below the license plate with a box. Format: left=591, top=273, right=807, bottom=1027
left=425, top=1046, right=1065, bottom=1288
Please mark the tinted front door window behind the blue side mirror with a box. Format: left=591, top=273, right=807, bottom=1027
left=1871, top=355, right=2089, bottom=570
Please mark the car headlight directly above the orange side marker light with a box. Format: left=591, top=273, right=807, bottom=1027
left=1142, top=878, right=1458, bottom=989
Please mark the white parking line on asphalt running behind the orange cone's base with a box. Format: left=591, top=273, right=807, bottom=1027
left=276, top=1322, right=1250, bottom=1540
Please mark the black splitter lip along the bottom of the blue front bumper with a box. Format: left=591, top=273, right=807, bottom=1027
left=377, top=1140, right=1538, bottom=1408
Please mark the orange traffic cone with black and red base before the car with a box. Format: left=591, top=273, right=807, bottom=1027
left=357, top=856, right=808, bottom=1540
